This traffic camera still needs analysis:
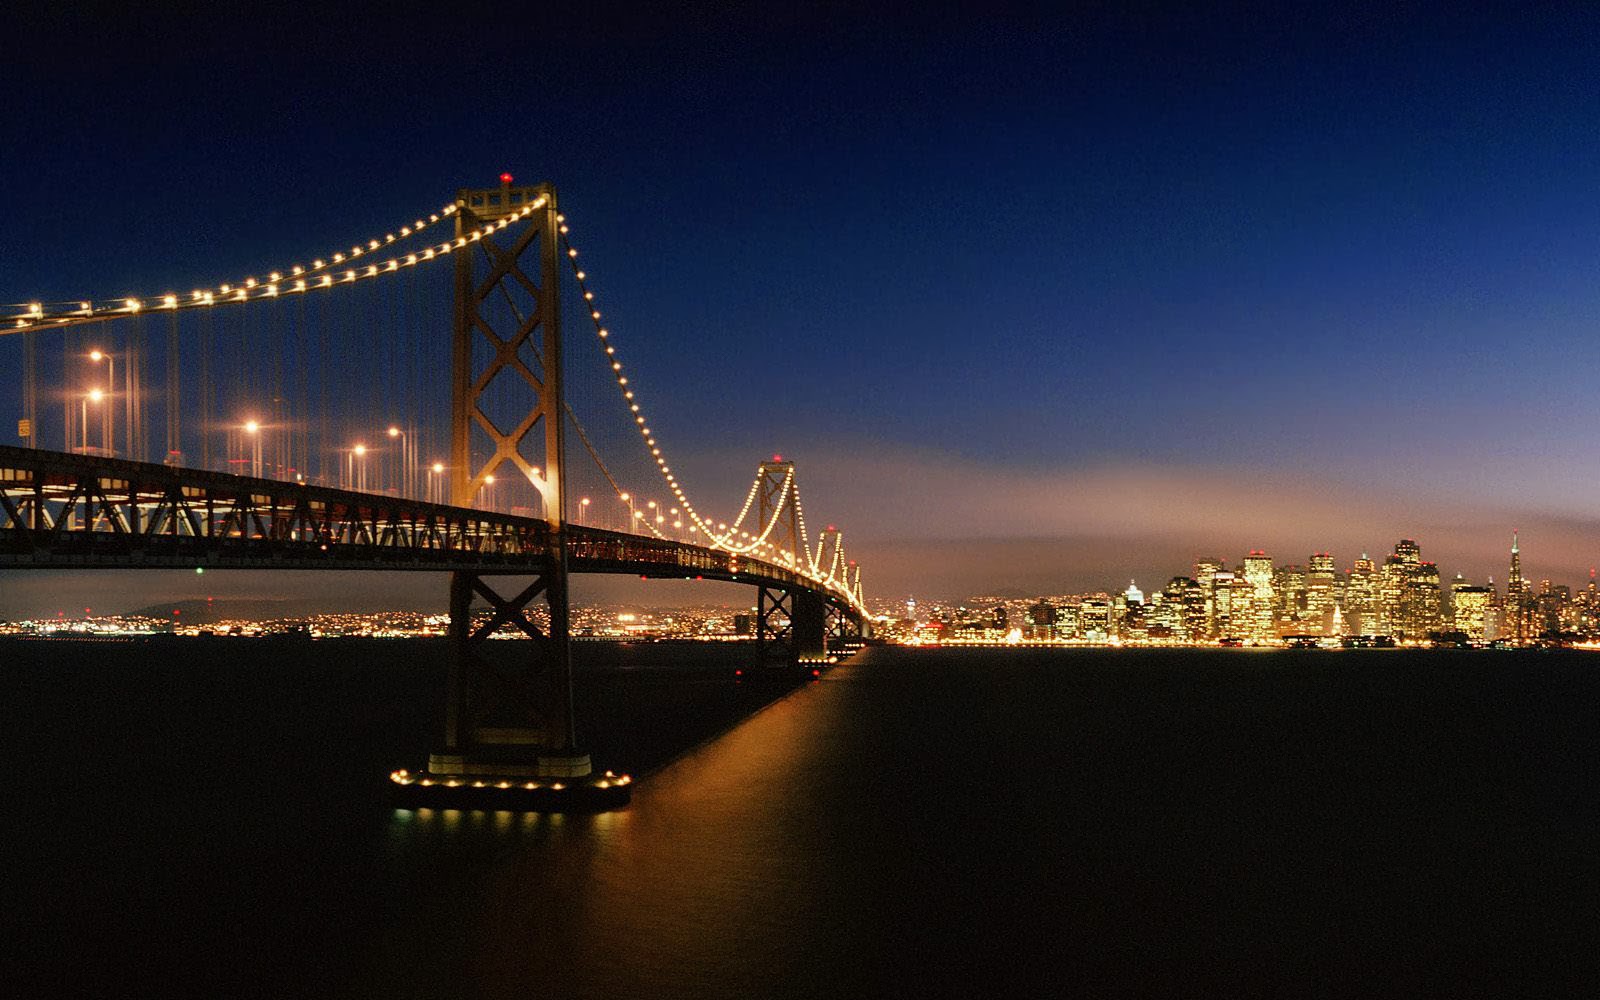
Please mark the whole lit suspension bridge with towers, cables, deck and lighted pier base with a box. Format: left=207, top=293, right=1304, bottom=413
left=0, top=174, right=867, bottom=806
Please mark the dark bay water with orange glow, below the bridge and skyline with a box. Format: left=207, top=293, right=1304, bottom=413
left=0, top=643, right=1600, bottom=997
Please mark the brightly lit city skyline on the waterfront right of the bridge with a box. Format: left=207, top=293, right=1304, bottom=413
left=874, top=534, right=1600, bottom=648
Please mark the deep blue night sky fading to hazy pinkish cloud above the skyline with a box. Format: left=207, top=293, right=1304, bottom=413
left=0, top=3, right=1600, bottom=616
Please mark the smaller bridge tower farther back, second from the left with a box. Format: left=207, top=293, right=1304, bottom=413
left=755, top=454, right=827, bottom=664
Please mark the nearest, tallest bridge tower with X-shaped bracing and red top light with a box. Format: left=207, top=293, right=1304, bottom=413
left=429, top=174, right=590, bottom=778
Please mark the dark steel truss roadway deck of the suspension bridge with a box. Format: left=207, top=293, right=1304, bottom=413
left=0, top=445, right=856, bottom=616
